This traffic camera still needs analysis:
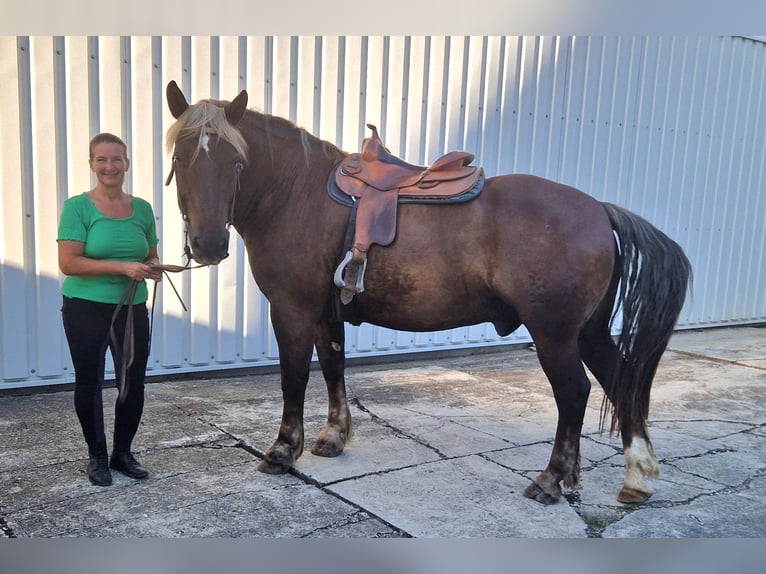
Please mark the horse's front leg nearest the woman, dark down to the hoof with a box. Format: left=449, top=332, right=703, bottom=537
left=258, top=312, right=314, bottom=474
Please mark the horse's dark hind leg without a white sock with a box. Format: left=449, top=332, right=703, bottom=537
left=524, top=334, right=590, bottom=504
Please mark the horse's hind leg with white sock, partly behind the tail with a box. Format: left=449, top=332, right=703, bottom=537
left=580, top=302, right=660, bottom=503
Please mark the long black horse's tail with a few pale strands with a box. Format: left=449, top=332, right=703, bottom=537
left=601, top=203, right=692, bottom=432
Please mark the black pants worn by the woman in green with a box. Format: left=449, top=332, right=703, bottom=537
left=61, top=297, right=149, bottom=452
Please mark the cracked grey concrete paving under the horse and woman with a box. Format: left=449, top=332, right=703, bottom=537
left=0, top=327, right=766, bottom=538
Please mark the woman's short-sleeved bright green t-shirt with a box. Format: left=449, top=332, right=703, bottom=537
left=58, top=193, right=158, bottom=304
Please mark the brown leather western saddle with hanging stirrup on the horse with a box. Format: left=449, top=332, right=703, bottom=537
left=327, top=124, right=484, bottom=304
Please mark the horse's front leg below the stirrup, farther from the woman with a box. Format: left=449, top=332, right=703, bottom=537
left=311, top=322, right=351, bottom=456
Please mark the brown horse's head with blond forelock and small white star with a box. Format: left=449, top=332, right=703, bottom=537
left=166, top=81, right=247, bottom=265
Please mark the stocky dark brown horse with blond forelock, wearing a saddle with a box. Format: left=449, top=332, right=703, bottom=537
left=167, top=82, right=691, bottom=504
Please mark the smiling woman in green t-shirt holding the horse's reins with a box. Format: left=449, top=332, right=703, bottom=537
left=58, top=133, right=162, bottom=486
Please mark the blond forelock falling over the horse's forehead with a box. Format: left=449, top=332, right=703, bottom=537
left=165, top=100, right=247, bottom=163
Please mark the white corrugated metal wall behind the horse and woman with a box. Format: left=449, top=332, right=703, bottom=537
left=0, top=37, right=766, bottom=389
